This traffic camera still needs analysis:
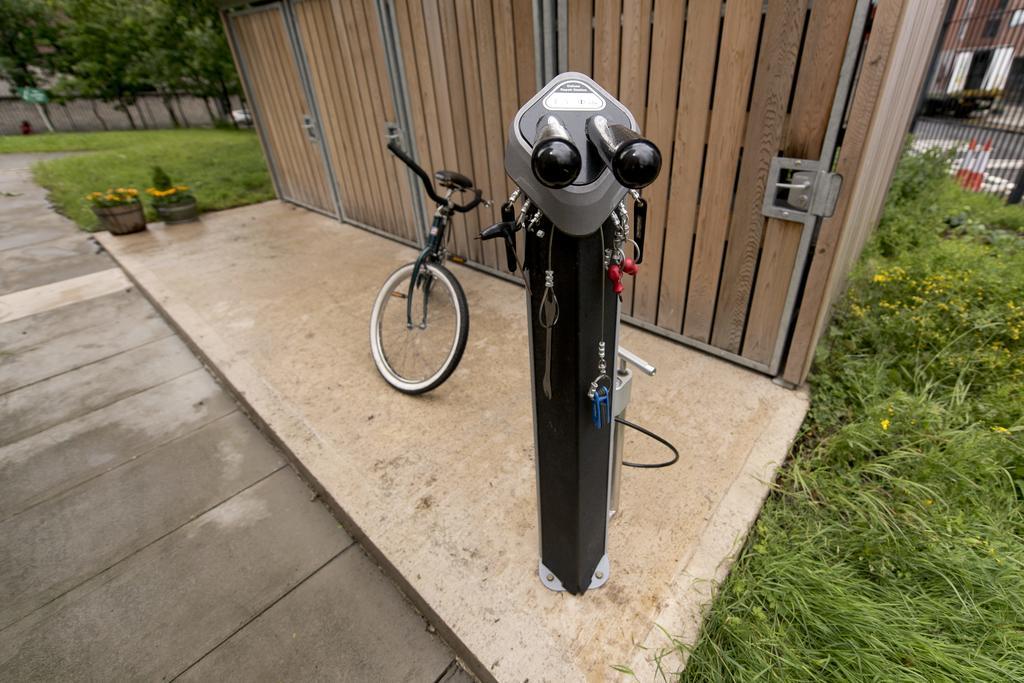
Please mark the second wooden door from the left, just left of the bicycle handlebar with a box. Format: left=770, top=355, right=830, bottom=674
left=292, top=0, right=417, bottom=243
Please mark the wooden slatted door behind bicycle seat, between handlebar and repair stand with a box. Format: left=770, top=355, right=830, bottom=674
left=389, top=0, right=538, bottom=271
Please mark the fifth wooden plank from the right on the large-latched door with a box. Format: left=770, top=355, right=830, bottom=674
left=623, top=2, right=684, bottom=323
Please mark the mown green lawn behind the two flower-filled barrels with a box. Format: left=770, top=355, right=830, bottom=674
left=0, top=129, right=274, bottom=230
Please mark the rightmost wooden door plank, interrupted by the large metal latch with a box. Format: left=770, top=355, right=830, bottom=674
left=741, top=0, right=857, bottom=364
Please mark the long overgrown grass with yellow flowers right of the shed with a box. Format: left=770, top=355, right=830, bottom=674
left=666, top=147, right=1024, bottom=683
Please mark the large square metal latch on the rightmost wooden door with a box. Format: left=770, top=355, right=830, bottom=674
left=761, top=157, right=843, bottom=221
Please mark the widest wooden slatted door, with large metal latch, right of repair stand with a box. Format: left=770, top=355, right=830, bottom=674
left=566, top=0, right=863, bottom=374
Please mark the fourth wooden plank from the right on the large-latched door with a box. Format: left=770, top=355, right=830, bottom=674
left=655, top=1, right=722, bottom=332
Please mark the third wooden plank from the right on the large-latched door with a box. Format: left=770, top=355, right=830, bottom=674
left=683, top=2, right=761, bottom=342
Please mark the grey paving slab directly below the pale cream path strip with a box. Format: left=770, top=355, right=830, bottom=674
left=0, top=291, right=174, bottom=394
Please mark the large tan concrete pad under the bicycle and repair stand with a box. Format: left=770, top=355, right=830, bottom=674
left=100, top=202, right=807, bottom=681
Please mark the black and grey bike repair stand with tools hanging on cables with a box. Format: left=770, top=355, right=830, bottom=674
left=497, top=73, right=660, bottom=594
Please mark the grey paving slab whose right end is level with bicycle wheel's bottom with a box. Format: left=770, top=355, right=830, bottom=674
left=0, top=369, right=236, bottom=520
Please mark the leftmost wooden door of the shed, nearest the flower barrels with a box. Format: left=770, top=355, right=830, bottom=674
left=227, top=3, right=337, bottom=216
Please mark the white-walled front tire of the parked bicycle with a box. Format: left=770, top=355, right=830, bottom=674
left=370, top=263, right=469, bottom=394
